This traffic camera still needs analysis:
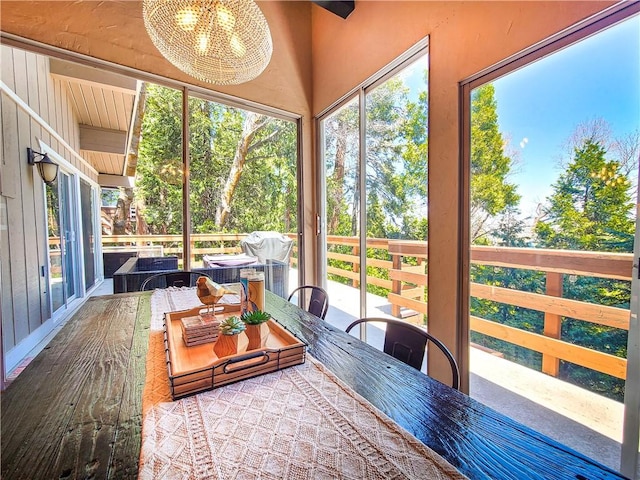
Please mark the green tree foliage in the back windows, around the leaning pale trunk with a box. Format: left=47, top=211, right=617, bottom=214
left=135, top=85, right=298, bottom=238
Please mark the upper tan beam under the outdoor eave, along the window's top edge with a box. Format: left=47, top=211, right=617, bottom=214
left=49, top=58, right=137, bottom=95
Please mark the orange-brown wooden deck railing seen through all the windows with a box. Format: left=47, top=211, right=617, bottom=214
left=97, top=234, right=632, bottom=379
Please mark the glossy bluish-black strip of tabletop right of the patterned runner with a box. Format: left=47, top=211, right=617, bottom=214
left=266, top=295, right=624, bottom=480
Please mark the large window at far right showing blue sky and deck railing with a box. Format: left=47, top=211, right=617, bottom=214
left=463, top=5, right=640, bottom=471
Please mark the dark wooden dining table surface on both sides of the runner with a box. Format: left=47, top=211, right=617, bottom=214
left=2, top=292, right=623, bottom=480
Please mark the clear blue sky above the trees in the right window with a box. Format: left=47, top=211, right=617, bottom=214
left=494, top=16, right=640, bottom=221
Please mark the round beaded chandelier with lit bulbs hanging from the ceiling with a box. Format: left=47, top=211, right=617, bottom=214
left=142, top=0, right=273, bottom=85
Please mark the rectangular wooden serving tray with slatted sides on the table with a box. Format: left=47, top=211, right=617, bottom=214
left=164, top=306, right=307, bottom=400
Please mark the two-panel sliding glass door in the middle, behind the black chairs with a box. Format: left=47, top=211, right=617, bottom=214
left=319, top=46, right=428, bottom=338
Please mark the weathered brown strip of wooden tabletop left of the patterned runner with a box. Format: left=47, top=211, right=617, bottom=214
left=1, top=294, right=150, bottom=480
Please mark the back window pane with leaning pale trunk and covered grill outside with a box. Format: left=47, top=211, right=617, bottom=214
left=189, top=96, right=298, bottom=274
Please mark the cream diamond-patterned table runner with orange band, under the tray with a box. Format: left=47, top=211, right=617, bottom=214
left=139, top=289, right=465, bottom=480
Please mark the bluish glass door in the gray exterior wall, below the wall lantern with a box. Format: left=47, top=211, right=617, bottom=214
left=47, top=172, right=77, bottom=314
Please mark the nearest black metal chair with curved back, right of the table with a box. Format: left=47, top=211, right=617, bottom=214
left=346, top=317, right=460, bottom=390
